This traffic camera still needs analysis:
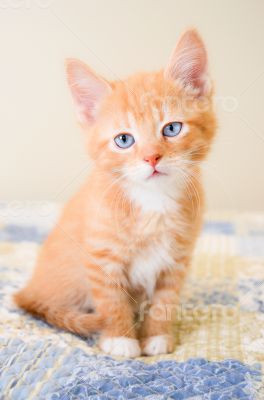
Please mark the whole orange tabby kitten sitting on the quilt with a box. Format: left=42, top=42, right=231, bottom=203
left=15, top=30, right=215, bottom=357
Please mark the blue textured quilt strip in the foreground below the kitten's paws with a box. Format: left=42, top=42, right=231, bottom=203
left=0, top=339, right=260, bottom=400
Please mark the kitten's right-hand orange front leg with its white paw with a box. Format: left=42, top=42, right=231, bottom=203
left=139, top=270, right=185, bottom=355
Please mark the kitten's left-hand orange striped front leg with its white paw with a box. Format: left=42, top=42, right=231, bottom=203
left=89, top=266, right=141, bottom=357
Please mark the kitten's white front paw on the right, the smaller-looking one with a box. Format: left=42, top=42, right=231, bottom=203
left=141, top=335, right=173, bottom=356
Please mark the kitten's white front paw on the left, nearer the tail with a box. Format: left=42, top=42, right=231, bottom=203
left=100, top=336, right=141, bottom=358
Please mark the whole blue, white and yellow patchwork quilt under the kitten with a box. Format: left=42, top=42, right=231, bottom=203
left=0, top=202, right=264, bottom=400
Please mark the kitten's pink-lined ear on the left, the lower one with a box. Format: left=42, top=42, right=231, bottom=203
left=66, top=59, right=111, bottom=124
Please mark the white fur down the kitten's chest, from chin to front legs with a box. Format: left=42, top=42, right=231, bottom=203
left=125, top=178, right=182, bottom=297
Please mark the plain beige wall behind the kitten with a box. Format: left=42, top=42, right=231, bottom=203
left=0, top=0, right=264, bottom=210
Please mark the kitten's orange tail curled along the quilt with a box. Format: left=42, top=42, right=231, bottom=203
left=14, top=290, right=107, bottom=336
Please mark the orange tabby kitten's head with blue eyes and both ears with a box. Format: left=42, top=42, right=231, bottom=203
left=67, top=30, right=215, bottom=202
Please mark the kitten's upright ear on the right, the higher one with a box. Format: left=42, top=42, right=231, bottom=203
left=164, top=29, right=210, bottom=95
